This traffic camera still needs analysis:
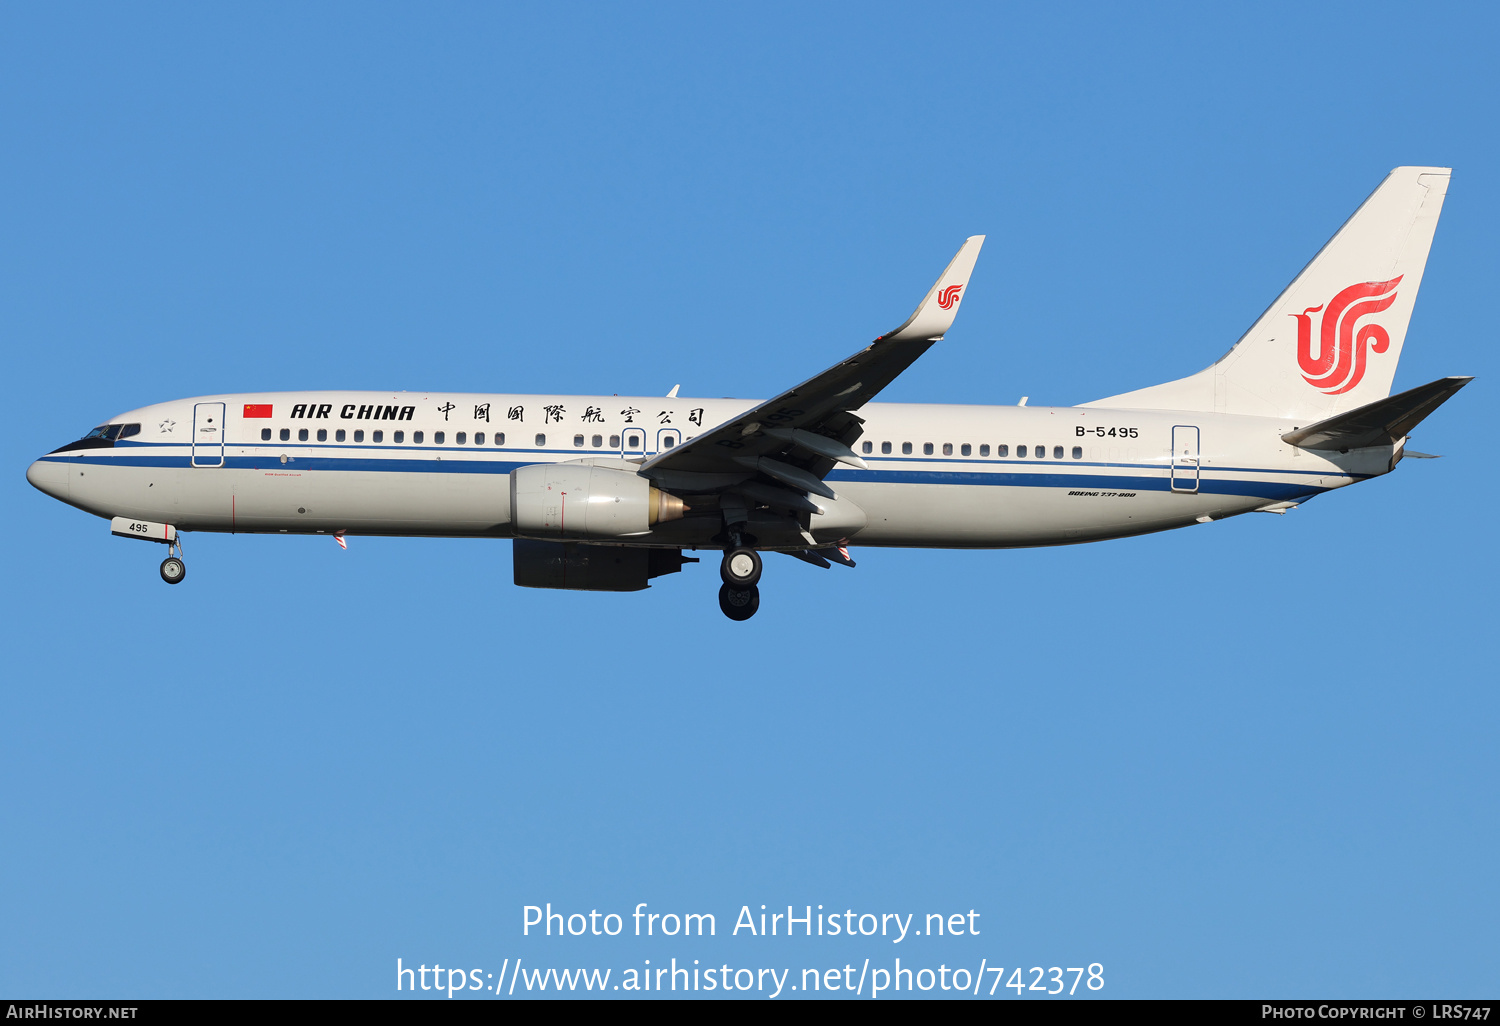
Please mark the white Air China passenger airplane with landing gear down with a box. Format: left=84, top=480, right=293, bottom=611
left=27, top=167, right=1472, bottom=621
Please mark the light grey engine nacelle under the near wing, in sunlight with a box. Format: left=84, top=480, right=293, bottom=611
left=510, top=462, right=687, bottom=539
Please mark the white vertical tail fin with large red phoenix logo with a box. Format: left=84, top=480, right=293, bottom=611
left=1083, top=168, right=1451, bottom=420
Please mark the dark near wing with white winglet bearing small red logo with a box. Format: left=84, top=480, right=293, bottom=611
left=641, top=236, right=984, bottom=512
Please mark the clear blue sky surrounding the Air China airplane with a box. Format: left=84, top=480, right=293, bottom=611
left=0, top=3, right=1500, bottom=998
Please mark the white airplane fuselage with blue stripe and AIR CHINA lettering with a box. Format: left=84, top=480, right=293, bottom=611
left=29, top=392, right=1400, bottom=548
